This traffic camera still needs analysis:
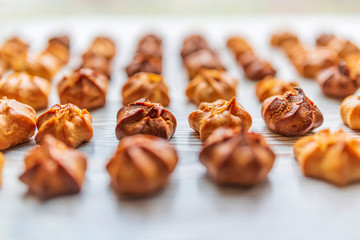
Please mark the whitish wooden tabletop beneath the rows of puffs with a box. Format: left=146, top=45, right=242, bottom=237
left=0, top=16, right=360, bottom=240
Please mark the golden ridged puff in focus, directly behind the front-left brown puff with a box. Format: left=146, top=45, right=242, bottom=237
left=35, top=103, right=93, bottom=148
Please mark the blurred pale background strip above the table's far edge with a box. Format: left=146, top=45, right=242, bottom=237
left=0, top=0, right=360, bottom=21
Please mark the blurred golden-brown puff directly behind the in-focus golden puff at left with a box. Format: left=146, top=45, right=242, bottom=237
left=58, top=68, right=109, bottom=109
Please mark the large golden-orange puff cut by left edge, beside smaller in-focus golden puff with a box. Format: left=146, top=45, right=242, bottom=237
left=0, top=97, right=36, bottom=150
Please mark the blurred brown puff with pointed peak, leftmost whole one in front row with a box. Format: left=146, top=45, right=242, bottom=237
left=19, top=135, right=86, bottom=200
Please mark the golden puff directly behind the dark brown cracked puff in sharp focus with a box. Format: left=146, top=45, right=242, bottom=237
left=122, top=72, right=170, bottom=106
